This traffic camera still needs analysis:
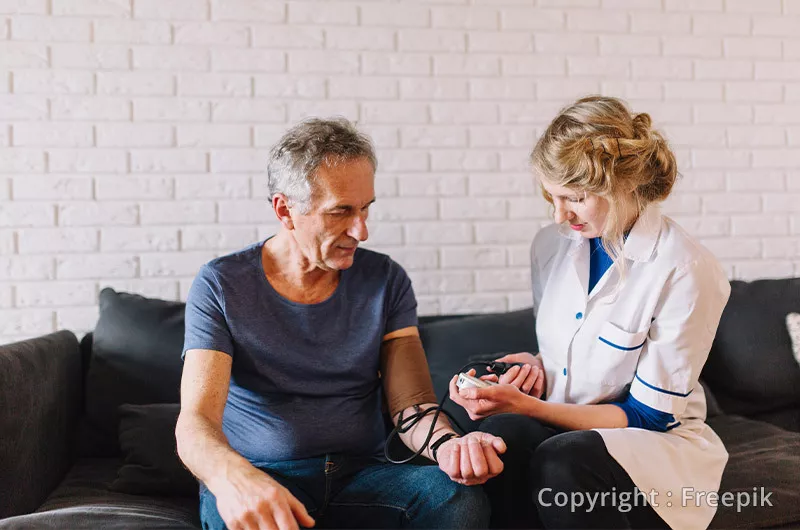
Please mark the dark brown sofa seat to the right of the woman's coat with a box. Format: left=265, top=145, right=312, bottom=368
left=708, top=415, right=800, bottom=528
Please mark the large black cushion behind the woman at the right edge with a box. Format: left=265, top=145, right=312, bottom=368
left=703, top=278, right=800, bottom=416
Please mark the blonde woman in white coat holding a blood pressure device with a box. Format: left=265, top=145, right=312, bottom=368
left=450, top=96, right=730, bottom=530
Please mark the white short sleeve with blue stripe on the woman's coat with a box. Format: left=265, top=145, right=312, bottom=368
left=630, top=262, right=730, bottom=416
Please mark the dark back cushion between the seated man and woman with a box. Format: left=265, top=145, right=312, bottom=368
left=419, top=308, right=539, bottom=431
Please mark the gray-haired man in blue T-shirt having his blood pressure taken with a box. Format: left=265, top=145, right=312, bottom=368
left=176, top=119, right=505, bottom=530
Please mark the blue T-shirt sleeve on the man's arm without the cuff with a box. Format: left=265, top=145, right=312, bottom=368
left=186, top=265, right=233, bottom=358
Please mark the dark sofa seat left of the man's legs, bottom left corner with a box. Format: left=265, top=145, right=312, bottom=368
left=0, top=458, right=200, bottom=530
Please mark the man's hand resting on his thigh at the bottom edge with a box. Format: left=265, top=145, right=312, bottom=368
left=209, top=463, right=315, bottom=530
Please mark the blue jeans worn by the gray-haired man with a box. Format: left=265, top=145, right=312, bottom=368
left=200, top=454, right=489, bottom=530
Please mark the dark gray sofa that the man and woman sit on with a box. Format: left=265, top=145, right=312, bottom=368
left=0, top=279, right=800, bottom=530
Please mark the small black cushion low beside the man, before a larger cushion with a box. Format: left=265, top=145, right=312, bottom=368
left=111, top=403, right=198, bottom=497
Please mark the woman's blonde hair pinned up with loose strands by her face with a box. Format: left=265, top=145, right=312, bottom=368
left=531, top=96, right=678, bottom=280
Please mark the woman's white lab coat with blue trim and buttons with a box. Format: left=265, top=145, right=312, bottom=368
left=531, top=205, right=730, bottom=530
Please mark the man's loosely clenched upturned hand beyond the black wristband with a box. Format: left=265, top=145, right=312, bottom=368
left=436, top=432, right=506, bottom=486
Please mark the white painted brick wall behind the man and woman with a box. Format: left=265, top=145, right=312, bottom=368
left=0, top=0, right=800, bottom=342
